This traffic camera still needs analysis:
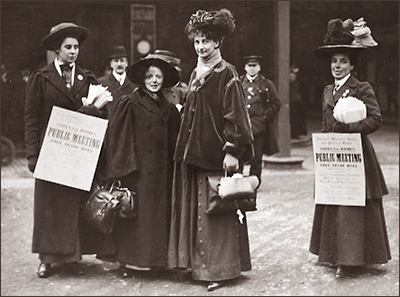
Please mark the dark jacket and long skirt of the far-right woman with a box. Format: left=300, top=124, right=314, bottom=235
left=310, top=76, right=391, bottom=266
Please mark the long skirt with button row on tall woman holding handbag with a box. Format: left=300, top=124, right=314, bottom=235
left=168, top=164, right=251, bottom=281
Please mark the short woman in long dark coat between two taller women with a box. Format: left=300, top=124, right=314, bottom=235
left=98, top=54, right=180, bottom=277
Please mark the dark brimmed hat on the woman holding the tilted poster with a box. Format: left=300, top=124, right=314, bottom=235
left=42, top=23, right=89, bottom=50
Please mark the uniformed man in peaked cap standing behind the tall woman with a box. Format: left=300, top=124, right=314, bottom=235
left=240, top=56, right=281, bottom=184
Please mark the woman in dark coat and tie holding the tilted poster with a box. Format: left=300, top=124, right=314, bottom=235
left=25, top=23, right=107, bottom=277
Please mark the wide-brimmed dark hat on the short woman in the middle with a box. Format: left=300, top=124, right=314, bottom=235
left=126, top=54, right=179, bottom=88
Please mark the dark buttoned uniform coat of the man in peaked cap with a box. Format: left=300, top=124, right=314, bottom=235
left=240, top=74, right=281, bottom=156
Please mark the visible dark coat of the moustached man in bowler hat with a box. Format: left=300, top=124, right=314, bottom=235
left=98, top=72, right=137, bottom=119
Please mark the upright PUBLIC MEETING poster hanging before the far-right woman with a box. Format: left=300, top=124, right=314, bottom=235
left=312, top=133, right=365, bottom=206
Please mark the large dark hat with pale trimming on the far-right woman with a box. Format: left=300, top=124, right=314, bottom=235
left=313, top=18, right=378, bottom=60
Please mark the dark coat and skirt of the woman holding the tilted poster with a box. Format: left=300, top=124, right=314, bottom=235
left=25, top=63, right=103, bottom=254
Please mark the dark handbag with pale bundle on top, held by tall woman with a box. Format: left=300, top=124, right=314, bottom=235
left=206, top=174, right=259, bottom=215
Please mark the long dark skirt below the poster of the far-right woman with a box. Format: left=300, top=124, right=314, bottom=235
left=310, top=199, right=391, bottom=266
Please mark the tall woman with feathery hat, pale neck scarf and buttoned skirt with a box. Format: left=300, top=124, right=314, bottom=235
left=168, top=9, right=253, bottom=290
